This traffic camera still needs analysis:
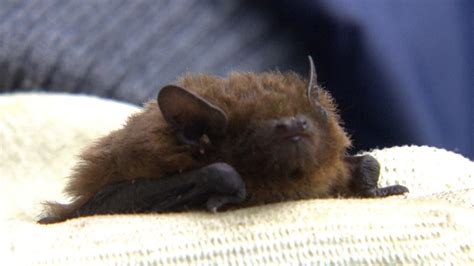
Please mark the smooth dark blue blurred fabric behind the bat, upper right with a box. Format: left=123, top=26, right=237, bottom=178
left=275, top=0, right=474, bottom=159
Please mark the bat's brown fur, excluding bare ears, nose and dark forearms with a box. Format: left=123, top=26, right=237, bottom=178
left=43, top=72, right=350, bottom=220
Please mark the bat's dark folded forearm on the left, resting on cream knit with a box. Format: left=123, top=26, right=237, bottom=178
left=73, top=163, right=246, bottom=216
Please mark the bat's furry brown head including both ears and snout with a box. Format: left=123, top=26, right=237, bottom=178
left=158, top=59, right=350, bottom=195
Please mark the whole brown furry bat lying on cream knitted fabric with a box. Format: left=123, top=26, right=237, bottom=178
left=39, top=57, right=408, bottom=223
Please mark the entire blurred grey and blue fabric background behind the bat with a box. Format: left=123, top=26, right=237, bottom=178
left=0, top=0, right=474, bottom=159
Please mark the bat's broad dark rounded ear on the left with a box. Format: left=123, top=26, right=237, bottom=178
left=157, top=85, right=227, bottom=144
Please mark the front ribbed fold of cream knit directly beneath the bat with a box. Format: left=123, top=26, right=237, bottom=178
left=1, top=200, right=474, bottom=265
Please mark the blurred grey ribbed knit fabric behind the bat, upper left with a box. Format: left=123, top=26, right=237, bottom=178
left=0, top=0, right=305, bottom=104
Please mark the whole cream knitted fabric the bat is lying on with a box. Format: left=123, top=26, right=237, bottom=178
left=0, top=94, right=474, bottom=265
